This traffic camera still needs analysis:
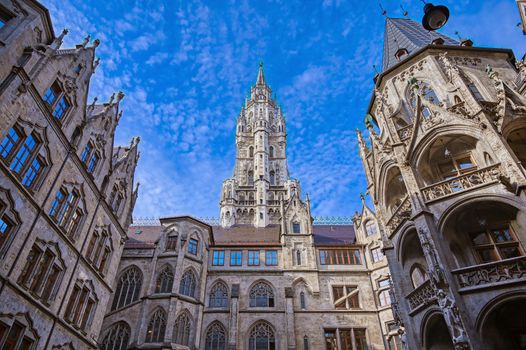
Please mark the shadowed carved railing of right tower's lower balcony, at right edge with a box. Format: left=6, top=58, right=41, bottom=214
left=452, top=256, right=526, bottom=290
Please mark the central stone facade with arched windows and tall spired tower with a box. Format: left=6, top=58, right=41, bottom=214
left=100, top=66, right=401, bottom=350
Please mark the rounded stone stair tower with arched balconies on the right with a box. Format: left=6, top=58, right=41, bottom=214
left=364, top=18, right=526, bottom=350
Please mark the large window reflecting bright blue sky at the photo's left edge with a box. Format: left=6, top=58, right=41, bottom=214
left=0, top=125, right=49, bottom=190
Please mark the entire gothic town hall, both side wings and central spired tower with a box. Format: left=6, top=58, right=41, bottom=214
left=0, top=0, right=526, bottom=350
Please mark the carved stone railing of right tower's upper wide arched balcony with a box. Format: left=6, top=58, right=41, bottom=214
left=421, top=163, right=501, bottom=202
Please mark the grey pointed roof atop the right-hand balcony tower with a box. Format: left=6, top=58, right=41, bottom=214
left=382, top=17, right=459, bottom=71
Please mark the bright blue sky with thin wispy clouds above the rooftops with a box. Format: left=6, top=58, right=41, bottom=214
left=43, top=0, right=526, bottom=217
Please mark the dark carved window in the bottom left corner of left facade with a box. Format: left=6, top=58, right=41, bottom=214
left=0, top=313, right=39, bottom=350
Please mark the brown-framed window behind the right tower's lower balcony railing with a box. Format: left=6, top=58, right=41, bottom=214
left=470, top=226, right=524, bottom=263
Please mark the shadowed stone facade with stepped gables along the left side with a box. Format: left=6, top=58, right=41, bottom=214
left=0, top=0, right=138, bottom=350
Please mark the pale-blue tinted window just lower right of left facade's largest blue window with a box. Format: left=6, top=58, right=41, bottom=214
left=49, top=185, right=84, bottom=241
